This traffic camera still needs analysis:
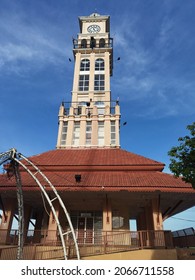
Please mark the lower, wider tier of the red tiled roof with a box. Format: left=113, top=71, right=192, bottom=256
left=0, top=171, right=192, bottom=192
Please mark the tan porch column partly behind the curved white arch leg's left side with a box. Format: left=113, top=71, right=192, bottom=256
left=46, top=202, right=60, bottom=241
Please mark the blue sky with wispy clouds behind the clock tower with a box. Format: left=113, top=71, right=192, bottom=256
left=0, top=0, right=195, bottom=229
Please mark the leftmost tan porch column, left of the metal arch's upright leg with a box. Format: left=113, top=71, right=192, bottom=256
left=0, top=198, right=16, bottom=244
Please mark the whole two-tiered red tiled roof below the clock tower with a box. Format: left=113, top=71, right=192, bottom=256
left=0, top=149, right=194, bottom=193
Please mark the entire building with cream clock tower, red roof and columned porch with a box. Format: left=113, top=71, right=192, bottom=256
left=0, top=13, right=195, bottom=254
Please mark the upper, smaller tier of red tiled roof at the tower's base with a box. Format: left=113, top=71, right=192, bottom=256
left=26, top=149, right=164, bottom=171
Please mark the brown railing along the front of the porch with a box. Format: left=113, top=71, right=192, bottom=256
left=0, top=230, right=173, bottom=259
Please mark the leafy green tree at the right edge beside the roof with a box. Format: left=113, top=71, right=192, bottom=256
left=168, top=122, right=195, bottom=189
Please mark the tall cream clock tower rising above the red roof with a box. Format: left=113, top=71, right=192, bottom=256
left=57, top=13, right=120, bottom=149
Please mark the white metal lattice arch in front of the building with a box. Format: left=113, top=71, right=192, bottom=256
left=0, top=149, right=80, bottom=260
